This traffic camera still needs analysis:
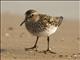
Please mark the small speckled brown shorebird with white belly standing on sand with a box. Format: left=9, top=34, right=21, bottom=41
left=20, top=9, right=63, bottom=53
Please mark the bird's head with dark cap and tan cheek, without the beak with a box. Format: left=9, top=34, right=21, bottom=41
left=25, top=9, right=39, bottom=22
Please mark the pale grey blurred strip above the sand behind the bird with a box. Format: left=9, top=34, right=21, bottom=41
left=1, top=1, right=79, bottom=20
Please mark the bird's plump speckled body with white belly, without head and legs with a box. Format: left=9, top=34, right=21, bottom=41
left=25, top=14, right=62, bottom=35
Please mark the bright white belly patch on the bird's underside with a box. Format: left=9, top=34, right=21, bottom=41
left=39, top=26, right=58, bottom=36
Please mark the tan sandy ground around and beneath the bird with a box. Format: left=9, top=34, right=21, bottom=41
left=0, top=12, right=80, bottom=60
